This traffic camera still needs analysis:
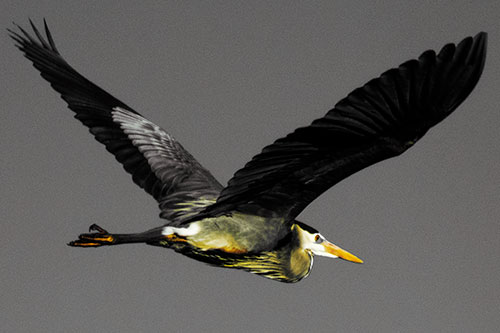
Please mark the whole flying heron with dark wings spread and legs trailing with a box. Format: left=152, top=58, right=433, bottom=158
left=9, top=20, right=487, bottom=282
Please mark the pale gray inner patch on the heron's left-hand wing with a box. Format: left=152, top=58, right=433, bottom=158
left=111, top=107, right=223, bottom=223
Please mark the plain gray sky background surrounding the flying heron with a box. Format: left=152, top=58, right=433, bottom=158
left=0, top=0, right=500, bottom=332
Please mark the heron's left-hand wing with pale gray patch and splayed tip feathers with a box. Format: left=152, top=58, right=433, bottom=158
left=9, top=20, right=222, bottom=223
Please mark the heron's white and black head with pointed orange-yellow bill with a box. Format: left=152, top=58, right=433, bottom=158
left=293, top=221, right=363, bottom=264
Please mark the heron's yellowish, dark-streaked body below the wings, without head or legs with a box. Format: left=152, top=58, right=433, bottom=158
left=158, top=219, right=326, bottom=282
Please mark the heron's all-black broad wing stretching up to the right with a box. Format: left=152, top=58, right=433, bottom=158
left=201, top=32, right=487, bottom=221
